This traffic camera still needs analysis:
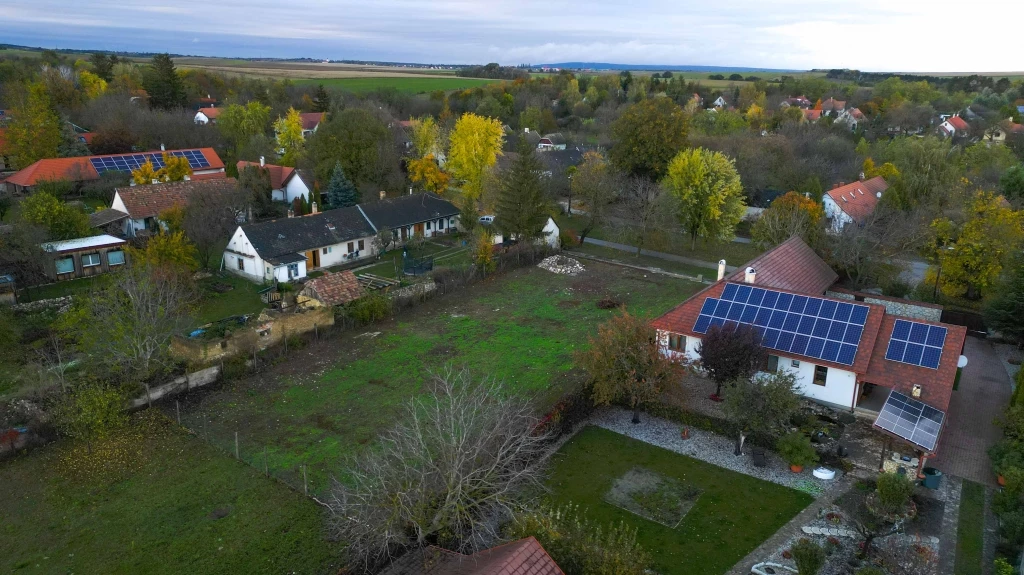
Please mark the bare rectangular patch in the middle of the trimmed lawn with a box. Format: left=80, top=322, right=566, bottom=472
left=604, top=467, right=701, bottom=529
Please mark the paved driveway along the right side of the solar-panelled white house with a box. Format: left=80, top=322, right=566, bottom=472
left=928, top=336, right=1012, bottom=486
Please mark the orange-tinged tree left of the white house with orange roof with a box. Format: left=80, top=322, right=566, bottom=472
left=751, top=191, right=824, bottom=250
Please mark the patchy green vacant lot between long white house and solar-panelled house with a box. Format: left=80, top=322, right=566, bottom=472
left=176, top=262, right=700, bottom=489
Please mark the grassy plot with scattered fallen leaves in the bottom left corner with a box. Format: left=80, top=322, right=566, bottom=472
left=0, top=412, right=338, bottom=575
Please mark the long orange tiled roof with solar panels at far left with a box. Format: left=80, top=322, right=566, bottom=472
left=0, top=147, right=225, bottom=193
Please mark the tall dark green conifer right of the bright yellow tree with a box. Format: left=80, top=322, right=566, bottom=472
left=495, top=137, right=548, bottom=240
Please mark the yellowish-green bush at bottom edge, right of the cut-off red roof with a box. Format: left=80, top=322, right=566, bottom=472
left=506, top=505, right=651, bottom=575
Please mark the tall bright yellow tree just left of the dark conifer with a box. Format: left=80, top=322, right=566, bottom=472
left=445, top=114, right=504, bottom=202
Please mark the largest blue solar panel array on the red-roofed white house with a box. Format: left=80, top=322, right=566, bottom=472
left=693, top=283, right=868, bottom=365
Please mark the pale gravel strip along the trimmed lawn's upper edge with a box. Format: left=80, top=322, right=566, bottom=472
left=590, top=407, right=843, bottom=497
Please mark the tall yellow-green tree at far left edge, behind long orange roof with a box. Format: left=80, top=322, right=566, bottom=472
left=5, top=83, right=60, bottom=168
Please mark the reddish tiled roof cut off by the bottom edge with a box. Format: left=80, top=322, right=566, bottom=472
left=382, top=537, right=564, bottom=575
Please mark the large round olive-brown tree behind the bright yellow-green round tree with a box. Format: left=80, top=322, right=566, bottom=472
left=610, top=98, right=689, bottom=179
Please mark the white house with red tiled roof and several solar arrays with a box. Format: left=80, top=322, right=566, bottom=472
left=652, top=237, right=967, bottom=460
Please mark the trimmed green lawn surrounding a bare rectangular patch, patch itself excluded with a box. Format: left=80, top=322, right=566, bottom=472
left=548, top=424, right=812, bottom=575
